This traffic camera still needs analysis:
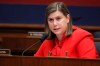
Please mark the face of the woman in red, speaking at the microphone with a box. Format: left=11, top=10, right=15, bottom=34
left=47, top=11, right=70, bottom=35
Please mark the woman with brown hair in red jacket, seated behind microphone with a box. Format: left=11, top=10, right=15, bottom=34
left=34, top=2, right=96, bottom=58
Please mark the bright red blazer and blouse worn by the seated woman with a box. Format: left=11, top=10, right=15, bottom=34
left=34, top=26, right=97, bottom=58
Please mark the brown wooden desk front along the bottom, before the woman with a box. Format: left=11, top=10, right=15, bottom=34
left=0, top=56, right=100, bottom=66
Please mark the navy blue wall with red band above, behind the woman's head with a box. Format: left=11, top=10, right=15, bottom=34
left=0, top=0, right=100, bottom=26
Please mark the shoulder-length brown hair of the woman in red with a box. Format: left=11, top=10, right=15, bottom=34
left=45, top=2, right=72, bottom=39
